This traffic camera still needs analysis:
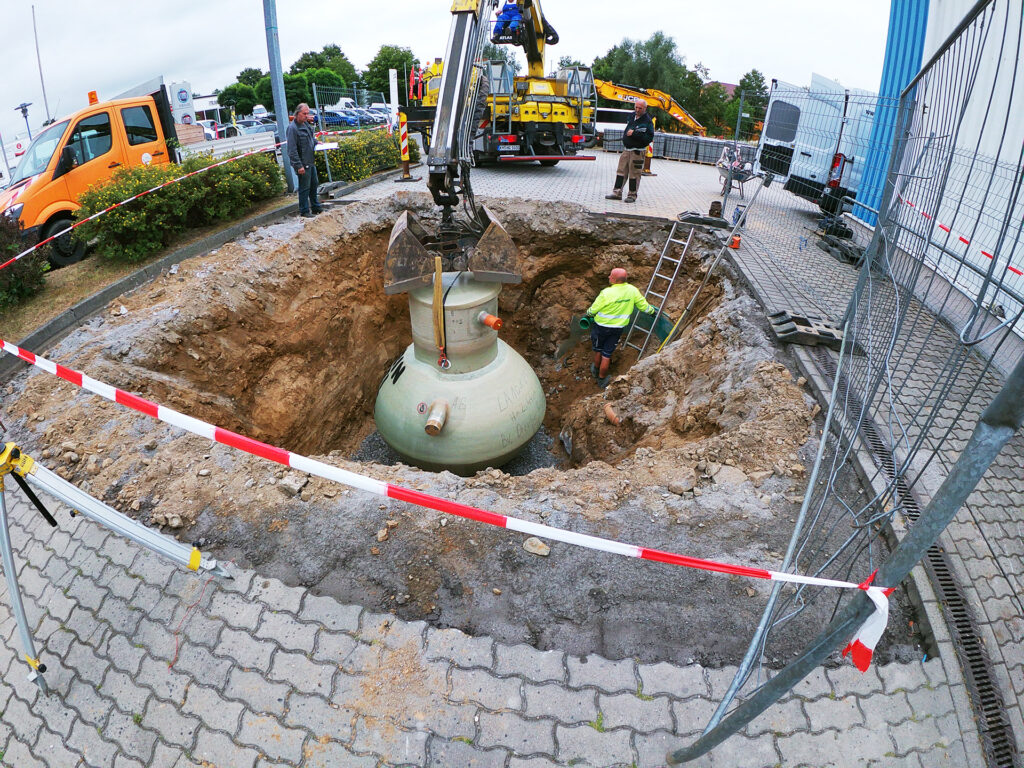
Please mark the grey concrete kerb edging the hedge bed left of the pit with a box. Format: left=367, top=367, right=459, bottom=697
left=0, top=168, right=401, bottom=382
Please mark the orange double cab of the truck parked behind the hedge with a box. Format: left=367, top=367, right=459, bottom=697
left=0, top=91, right=174, bottom=266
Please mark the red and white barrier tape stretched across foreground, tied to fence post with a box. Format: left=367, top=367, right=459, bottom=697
left=0, top=340, right=892, bottom=671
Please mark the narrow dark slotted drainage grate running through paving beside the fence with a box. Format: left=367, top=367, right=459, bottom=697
left=813, top=349, right=1020, bottom=768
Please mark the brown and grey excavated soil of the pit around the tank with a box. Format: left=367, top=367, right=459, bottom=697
left=5, top=193, right=916, bottom=666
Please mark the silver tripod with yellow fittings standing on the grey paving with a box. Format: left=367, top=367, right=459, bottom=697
left=0, top=442, right=232, bottom=693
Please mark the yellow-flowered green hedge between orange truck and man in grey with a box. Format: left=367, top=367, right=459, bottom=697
left=76, top=153, right=285, bottom=261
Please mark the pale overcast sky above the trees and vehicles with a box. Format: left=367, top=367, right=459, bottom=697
left=0, top=0, right=890, bottom=152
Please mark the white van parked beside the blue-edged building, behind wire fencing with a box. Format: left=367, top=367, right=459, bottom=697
left=757, top=74, right=878, bottom=214
